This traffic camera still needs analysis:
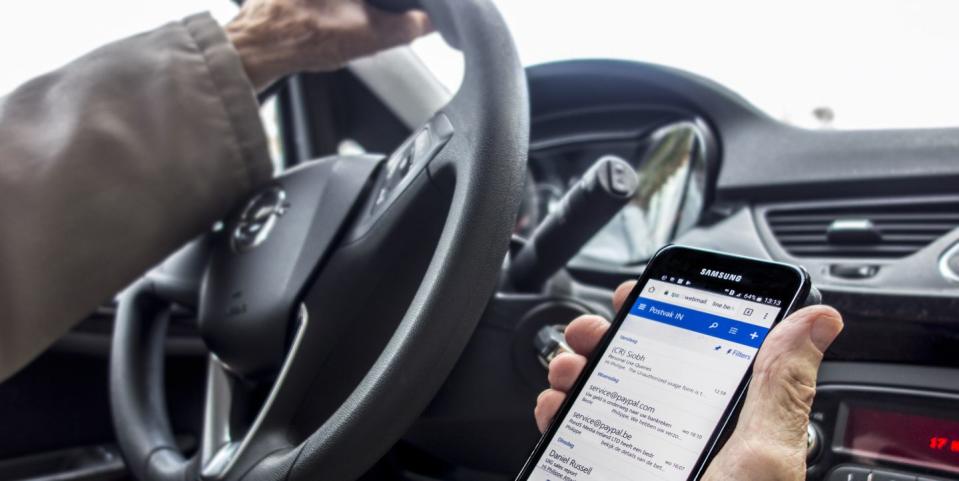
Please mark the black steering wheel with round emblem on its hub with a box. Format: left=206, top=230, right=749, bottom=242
left=110, top=0, right=529, bottom=481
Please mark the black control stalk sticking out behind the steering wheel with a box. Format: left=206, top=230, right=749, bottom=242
left=508, top=156, right=639, bottom=292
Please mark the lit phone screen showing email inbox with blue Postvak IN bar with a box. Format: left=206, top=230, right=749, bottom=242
left=530, top=280, right=779, bottom=481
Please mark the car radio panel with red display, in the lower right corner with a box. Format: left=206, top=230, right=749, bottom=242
left=807, top=363, right=959, bottom=481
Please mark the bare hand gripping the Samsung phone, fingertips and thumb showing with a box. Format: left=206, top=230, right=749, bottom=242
left=535, top=282, right=843, bottom=481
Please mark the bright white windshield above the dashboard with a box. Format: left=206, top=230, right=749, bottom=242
left=414, top=0, right=959, bottom=129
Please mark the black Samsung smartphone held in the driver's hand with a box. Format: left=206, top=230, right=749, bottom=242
left=516, top=245, right=811, bottom=481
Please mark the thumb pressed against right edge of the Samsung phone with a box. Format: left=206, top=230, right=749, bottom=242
left=736, top=306, right=843, bottom=452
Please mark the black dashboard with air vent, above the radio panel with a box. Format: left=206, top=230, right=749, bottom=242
left=529, top=61, right=959, bottom=367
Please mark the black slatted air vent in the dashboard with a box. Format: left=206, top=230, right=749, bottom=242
left=766, top=199, right=959, bottom=259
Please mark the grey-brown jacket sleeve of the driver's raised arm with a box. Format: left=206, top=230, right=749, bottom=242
left=0, top=14, right=272, bottom=381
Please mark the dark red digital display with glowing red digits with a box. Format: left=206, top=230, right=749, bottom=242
left=844, top=406, right=959, bottom=473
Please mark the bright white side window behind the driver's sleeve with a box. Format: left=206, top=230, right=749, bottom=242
left=0, top=0, right=283, bottom=171
